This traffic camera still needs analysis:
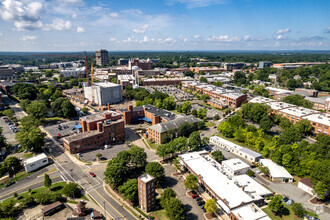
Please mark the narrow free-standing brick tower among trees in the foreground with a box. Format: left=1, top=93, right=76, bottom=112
left=138, top=174, right=156, bottom=212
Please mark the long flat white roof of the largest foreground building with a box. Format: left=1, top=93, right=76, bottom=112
left=180, top=151, right=253, bottom=208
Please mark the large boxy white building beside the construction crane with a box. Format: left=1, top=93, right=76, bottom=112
left=84, top=82, right=123, bottom=105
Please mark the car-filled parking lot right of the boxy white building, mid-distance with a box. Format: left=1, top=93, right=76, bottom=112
left=144, top=86, right=194, bottom=101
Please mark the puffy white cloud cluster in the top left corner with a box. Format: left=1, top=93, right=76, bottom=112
left=0, top=0, right=44, bottom=31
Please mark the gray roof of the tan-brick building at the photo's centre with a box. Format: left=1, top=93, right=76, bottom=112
left=149, top=115, right=200, bottom=133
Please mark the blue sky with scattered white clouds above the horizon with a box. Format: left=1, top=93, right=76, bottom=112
left=0, top=0, right=330, bottom=51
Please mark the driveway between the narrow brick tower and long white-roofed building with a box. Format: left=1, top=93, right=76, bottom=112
left=163, top=164, right=204, bottom=219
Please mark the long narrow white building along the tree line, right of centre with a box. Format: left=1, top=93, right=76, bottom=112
left=210, top=136, right=262, bottom=162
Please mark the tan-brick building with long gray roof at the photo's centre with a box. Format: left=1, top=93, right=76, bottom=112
left=148, top=115, right=200, bottom=144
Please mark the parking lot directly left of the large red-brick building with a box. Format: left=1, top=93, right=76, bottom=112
left=45, top=121, right=79, bottom=138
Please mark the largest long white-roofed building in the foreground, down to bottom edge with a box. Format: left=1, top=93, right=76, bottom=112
left=179, top=151, right=269, bottom=220
